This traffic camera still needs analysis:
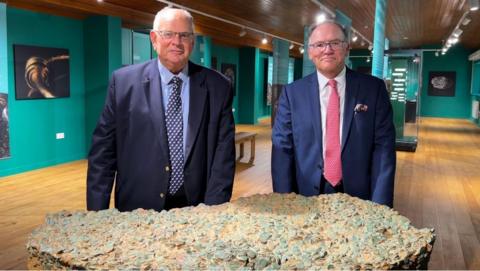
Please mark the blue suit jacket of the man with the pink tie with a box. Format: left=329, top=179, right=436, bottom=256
left=272, top=69, right=396, bottom=207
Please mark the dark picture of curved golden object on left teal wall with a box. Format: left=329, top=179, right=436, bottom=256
left=13, top=45, right=70, bottom=100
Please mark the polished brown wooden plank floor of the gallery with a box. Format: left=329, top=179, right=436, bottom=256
left=0, top=119, right=480, bottom=269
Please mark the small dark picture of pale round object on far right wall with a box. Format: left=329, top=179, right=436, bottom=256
left=428, top=71, right=456, bottom=96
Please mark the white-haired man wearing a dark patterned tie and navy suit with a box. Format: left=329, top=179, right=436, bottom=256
left=87, top=7, right=235, bottom=211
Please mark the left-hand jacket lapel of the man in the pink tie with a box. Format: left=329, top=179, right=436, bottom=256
left=305, top=72, right=323, bottom=166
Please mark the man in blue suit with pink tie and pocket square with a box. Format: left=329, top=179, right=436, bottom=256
left=272, top=21, right=396, bottom=207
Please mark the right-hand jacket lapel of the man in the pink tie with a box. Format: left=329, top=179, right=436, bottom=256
left=342, top=68, right=359, bottom=151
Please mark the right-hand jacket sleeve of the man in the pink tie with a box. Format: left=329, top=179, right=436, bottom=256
left=371, top=82, right=396, bottom=207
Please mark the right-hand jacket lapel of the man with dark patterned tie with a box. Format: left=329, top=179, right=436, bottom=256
left=185, top=62, right=207, bottom=161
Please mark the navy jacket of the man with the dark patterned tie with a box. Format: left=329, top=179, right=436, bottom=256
left=87, top=59, right=235, bottom=211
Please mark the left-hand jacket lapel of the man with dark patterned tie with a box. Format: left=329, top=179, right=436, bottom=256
left=142, top=59, right=168, bottom=160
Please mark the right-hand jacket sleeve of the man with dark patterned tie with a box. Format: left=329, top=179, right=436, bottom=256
left=205, top=83, right=235, bottom=205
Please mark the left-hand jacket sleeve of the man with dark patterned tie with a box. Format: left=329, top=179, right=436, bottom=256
left=87, top=76, right=117, bottom=211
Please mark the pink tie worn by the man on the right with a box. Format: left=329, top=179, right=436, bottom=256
left=324, top=79, right=342, bottom=186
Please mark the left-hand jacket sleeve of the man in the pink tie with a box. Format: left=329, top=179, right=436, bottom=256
left=272, top=87, right=296, bottom=193
